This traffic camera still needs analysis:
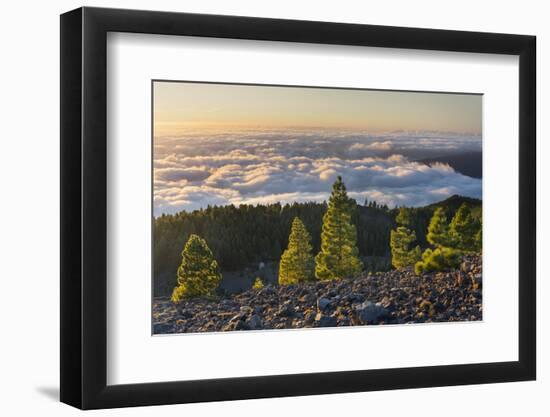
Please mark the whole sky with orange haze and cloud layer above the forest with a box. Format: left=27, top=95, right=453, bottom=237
left=153, top=82, right=482, bottom=216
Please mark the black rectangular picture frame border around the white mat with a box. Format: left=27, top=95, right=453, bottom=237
left=60, top=7, right=536, bottom=409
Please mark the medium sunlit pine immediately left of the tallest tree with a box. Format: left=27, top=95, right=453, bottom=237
left=279, top=217, right=315, bottom=285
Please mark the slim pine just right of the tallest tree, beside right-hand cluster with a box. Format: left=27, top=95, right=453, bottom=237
left=390, top=207, right=421, bottom=268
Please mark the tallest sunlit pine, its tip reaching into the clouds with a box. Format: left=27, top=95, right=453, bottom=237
left=315, top=177, right=363, bottom=280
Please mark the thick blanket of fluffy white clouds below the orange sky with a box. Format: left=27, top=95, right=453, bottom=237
left=154, top=130, right=481, bottom=216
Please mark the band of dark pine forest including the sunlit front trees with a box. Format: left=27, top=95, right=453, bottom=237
left=154, top=177, right=481, bottom=302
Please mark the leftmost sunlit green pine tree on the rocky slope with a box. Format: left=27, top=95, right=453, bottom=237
left=172, top=235, right=222, bottom=303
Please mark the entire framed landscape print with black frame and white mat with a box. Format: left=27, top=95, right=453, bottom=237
left=61, top=8, right=536, bottom=409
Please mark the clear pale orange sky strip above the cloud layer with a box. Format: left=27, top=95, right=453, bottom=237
left=154, top=81, right=482, bottom=136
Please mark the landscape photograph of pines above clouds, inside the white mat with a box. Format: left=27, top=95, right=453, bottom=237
left=150, top=80, right=483, bottom=335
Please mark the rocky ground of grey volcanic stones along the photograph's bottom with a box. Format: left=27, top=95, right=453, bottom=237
left=153, top=252, right=483, bottom=334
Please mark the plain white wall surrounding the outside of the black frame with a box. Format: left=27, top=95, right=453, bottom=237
left=0, top=0, right=550, bottom=417
